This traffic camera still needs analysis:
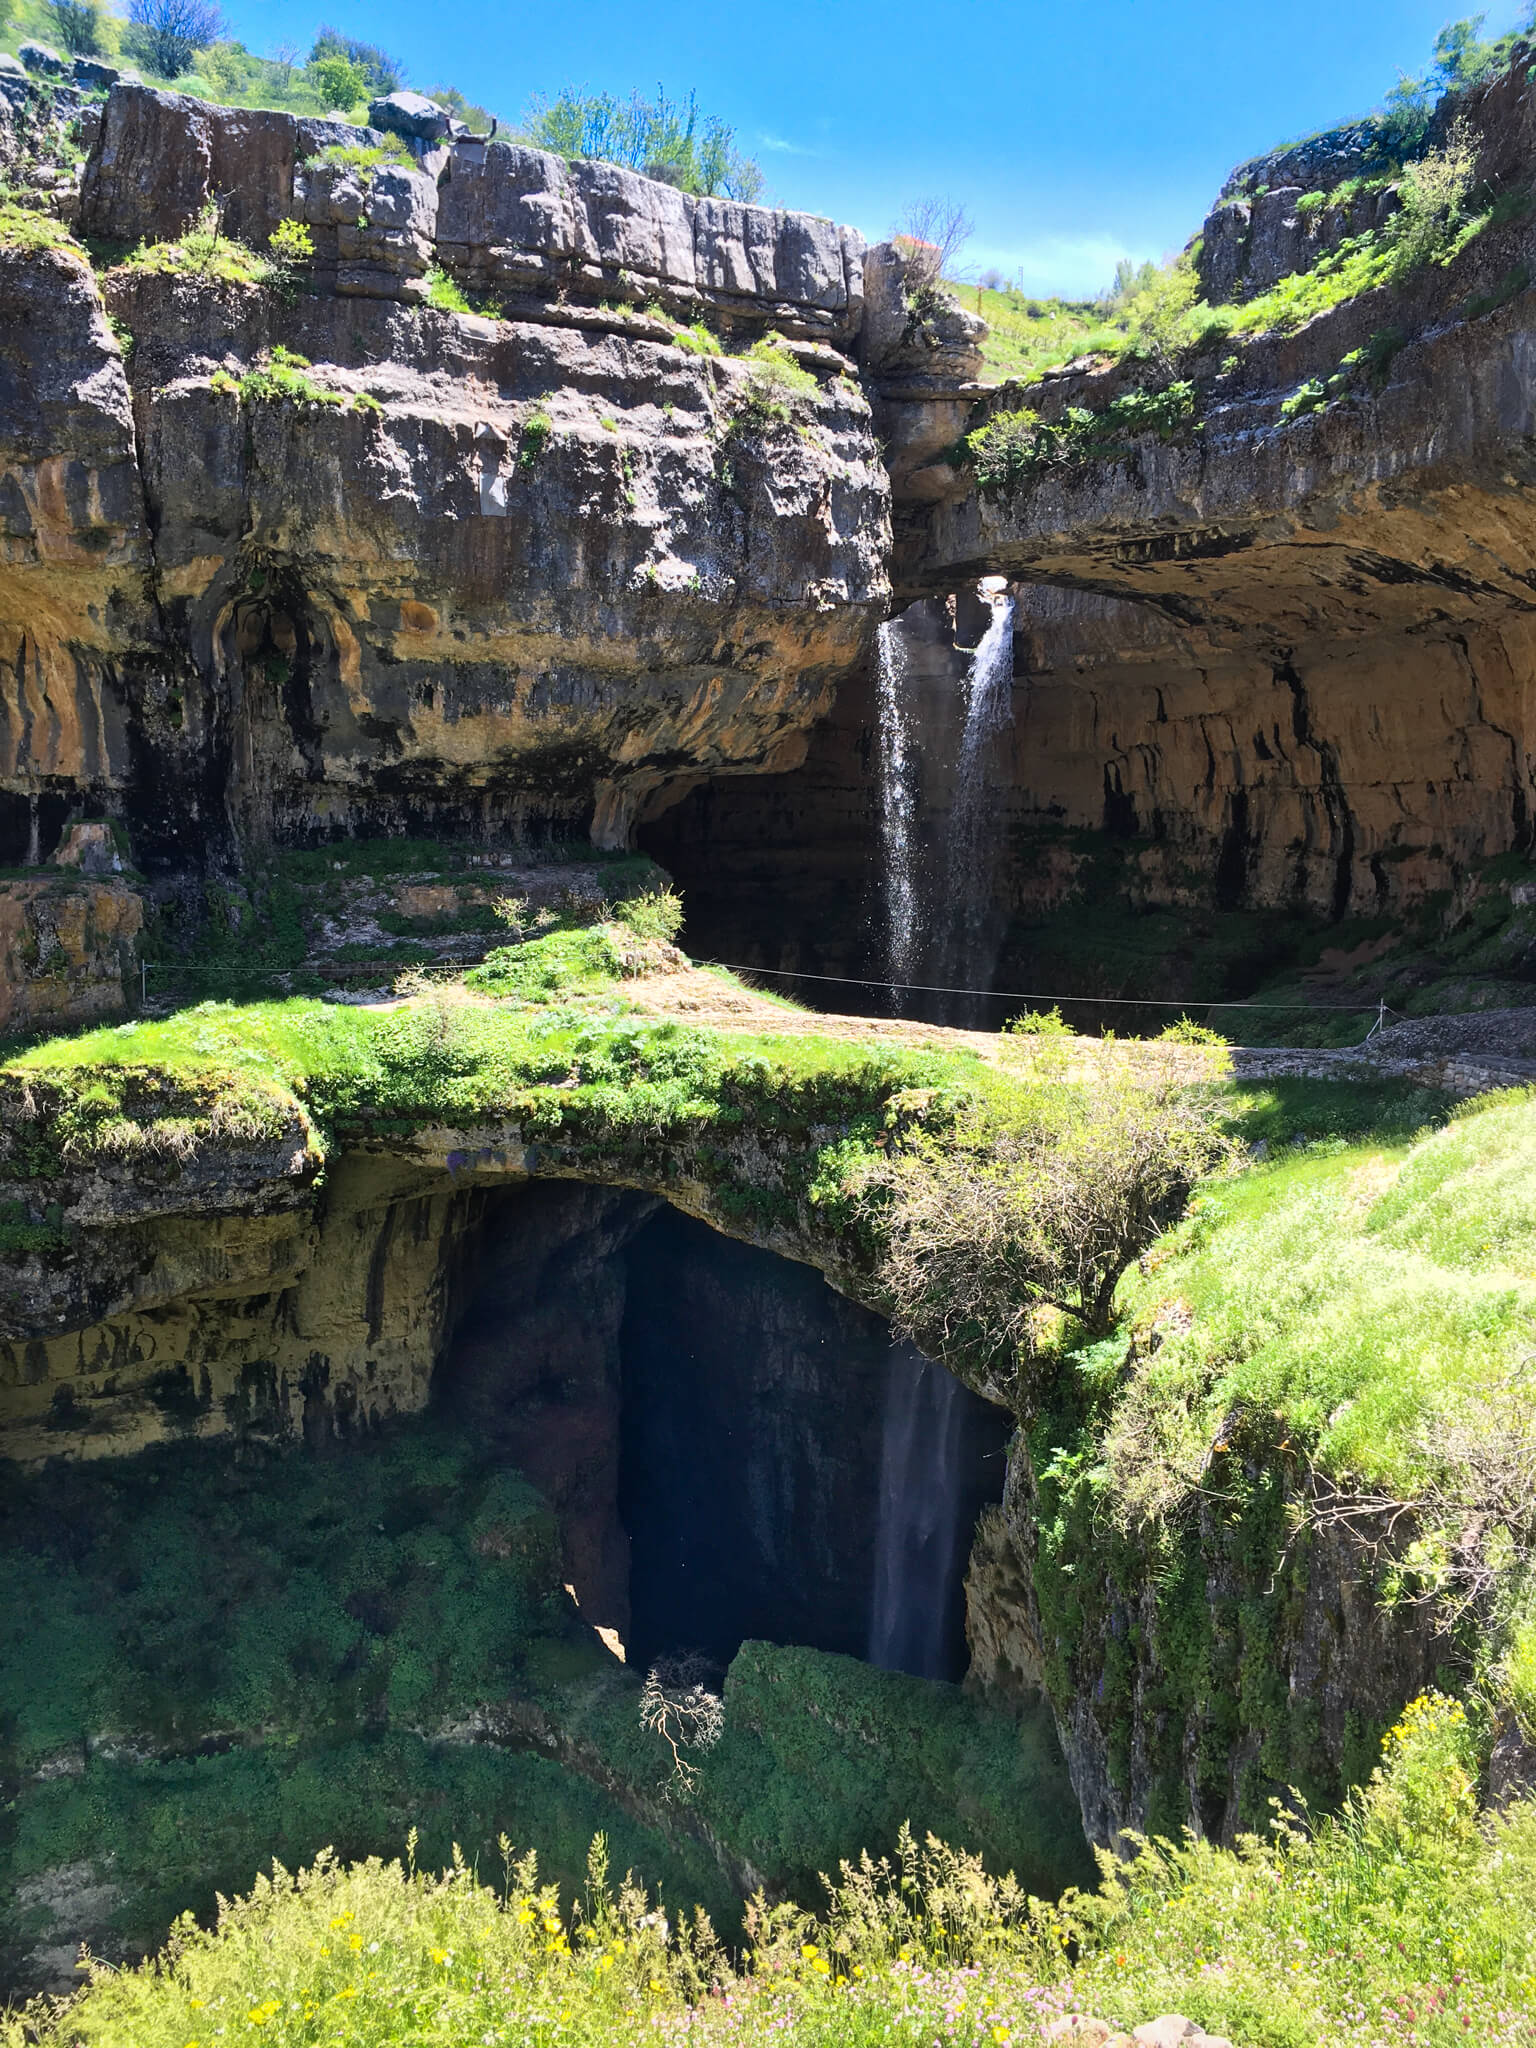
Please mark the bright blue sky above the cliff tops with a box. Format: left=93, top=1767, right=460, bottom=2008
left=225, top=0, right=1518, bottom=295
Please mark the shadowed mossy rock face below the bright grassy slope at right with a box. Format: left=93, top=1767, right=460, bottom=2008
left=967, top=1452, right=1450, bottom=1849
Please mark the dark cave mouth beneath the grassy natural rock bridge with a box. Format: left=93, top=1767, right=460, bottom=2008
left=434, top=1184, right=1008, bottom=1679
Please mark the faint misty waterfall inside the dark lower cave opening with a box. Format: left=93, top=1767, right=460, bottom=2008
left=868, top=1343, right=965, bottom=1677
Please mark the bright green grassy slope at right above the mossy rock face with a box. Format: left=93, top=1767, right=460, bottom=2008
left=1102, top=1094, right=1536, bottom=1520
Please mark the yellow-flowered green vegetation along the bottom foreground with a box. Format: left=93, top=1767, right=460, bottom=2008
left=8, top=1696, right=1536, bottom=2048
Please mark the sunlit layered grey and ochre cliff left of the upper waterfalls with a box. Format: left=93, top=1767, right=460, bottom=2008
left=0, top=86, right=889, bottom=870
